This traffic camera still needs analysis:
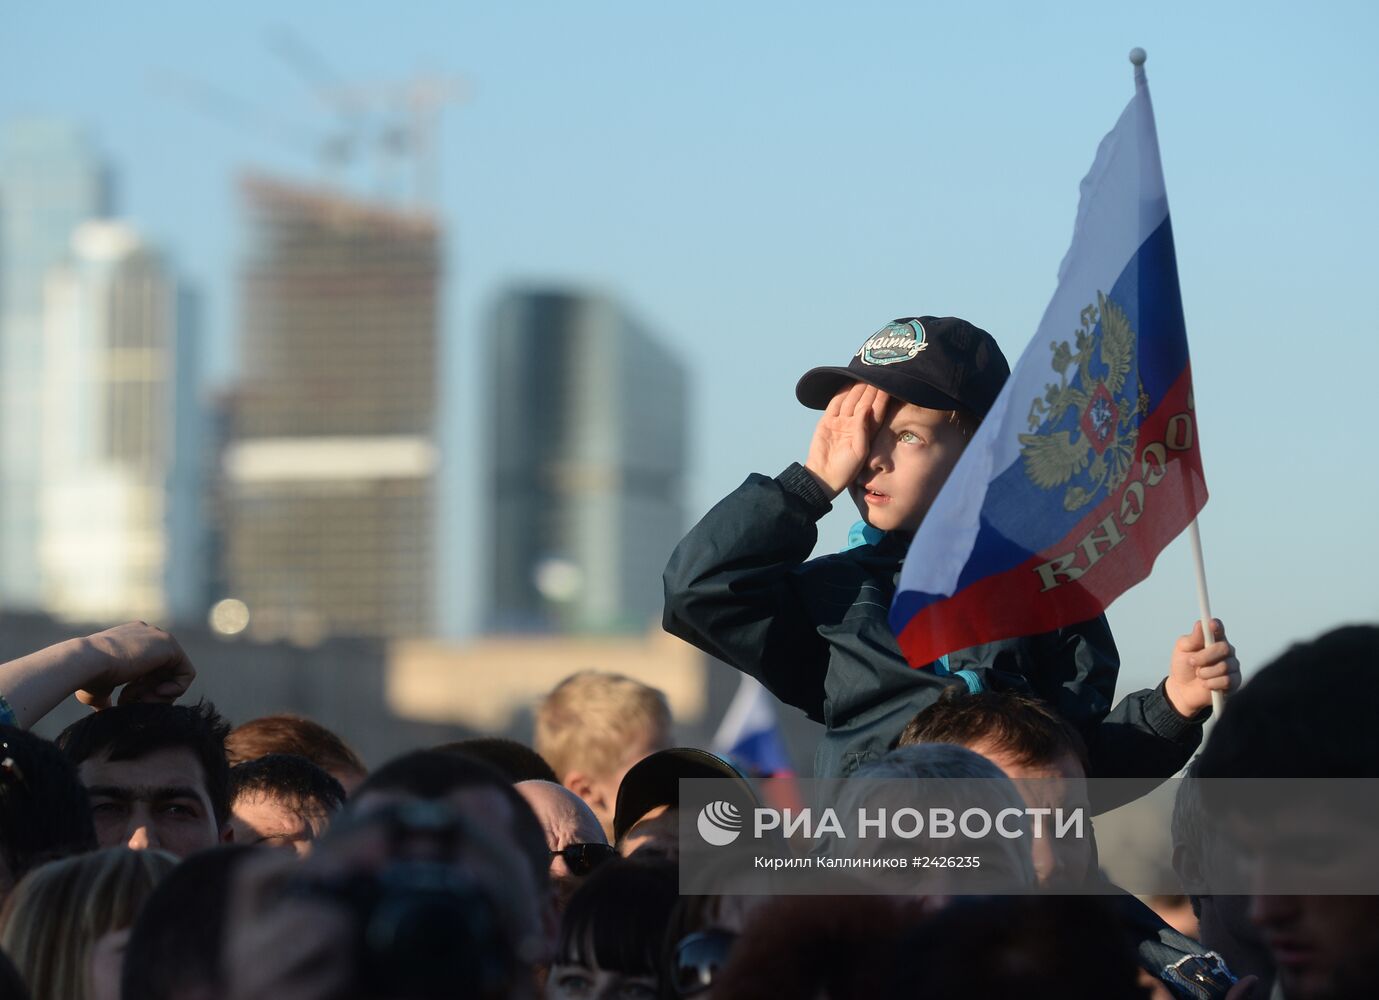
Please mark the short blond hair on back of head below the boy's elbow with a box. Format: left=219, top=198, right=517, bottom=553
left=536, top=670, right=670, bottom=781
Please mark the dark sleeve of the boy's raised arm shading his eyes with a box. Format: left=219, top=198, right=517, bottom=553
left=663, top=465, right=832, bottom=721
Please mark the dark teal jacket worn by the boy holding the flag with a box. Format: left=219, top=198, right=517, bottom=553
left=665, top=465, right=1205, bottom=783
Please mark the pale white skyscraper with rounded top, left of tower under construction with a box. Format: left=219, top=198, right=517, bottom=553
left=39, top=221, right=205, bottom=622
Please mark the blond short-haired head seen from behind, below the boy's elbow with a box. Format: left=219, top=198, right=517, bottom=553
left=536, top=670, right=670, bottom=840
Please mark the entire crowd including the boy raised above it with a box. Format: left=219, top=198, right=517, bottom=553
left=0, top=317, right=1379, bottom=1000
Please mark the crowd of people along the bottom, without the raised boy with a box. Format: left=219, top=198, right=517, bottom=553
left=0, top=615, right=1379, bottom=1000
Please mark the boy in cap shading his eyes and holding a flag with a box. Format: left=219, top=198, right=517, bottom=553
left=665, top=316, right=1238, bottom=778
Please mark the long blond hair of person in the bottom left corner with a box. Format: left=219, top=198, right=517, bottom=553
left=0, top=847, right=178, bottom=1000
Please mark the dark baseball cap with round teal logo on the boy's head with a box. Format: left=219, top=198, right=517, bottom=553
left=794, top=316, right=1011, bottom=418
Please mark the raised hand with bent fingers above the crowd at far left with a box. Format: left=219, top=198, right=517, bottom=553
left=69, top=622, right=196, bottom=709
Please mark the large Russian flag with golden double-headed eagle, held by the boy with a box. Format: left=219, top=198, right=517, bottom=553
left=891, top=52, right=1207, bottom=668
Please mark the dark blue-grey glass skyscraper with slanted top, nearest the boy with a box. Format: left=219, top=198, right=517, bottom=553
left=484, top=290, right=687, bottom=633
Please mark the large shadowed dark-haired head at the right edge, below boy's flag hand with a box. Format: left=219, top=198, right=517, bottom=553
left=1197, top=625, right=1379, bottom=1000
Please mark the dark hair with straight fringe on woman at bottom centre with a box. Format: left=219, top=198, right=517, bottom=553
left=554, top=858, right=678, bottom=978
